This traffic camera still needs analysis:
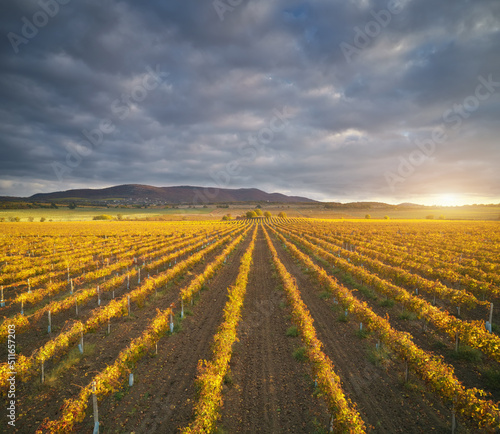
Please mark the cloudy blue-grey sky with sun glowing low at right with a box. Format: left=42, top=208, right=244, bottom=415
left=0, top=0, right=500, bottom=205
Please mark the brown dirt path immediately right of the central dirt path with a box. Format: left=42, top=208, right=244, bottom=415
left=272, top=229, right=451, bottom=434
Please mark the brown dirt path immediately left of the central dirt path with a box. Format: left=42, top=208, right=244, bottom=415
left=95, top=232, right=251, bottom=433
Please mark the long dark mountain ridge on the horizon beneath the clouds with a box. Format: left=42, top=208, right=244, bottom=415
left=28, top=184, right=316, bottom=204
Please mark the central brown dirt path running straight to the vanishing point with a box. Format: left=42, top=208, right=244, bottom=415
left=221, top=229, right=328, bottom=433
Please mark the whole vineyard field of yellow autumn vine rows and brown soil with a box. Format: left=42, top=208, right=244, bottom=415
left=0, top=220, right=500, bottom=433
